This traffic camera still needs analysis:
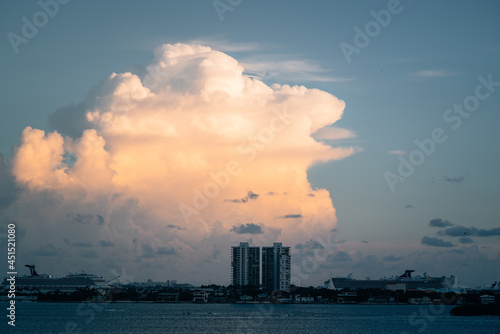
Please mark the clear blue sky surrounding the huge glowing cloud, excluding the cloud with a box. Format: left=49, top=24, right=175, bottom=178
left=0, top=0, right=500, bottom=285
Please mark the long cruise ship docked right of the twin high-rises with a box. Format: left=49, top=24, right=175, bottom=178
left=324, top=270, right=455, bottom=291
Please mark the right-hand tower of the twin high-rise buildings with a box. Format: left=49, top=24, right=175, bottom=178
left=262, top=242, right=290, bottom=292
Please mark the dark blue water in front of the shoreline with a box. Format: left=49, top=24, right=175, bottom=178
left=0, top=302, right=500, bottom=334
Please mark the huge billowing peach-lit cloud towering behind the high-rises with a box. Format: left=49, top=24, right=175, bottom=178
left=2, top=44, right=356, bottom=283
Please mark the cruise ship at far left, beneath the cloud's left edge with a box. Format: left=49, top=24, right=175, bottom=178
left=2, top=265, right=108, bottom=292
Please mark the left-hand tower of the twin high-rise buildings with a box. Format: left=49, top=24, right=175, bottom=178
left=231, top=242, right=260, bottom=287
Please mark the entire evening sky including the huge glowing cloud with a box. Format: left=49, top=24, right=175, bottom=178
left=0, top=0, right=500, bottom=287
